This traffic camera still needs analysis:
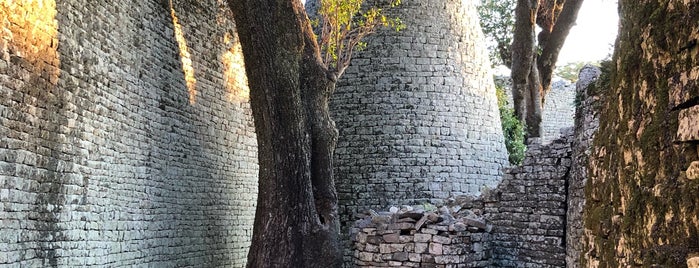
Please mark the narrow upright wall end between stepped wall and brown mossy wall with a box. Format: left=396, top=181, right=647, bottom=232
left=566, top=65, right=605, bottom=268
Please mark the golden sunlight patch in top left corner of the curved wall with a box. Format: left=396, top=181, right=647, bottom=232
left=0, top=0, right=60, bottom=81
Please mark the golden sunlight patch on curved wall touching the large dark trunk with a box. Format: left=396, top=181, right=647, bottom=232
left=221, top=33, right=250, bottom=102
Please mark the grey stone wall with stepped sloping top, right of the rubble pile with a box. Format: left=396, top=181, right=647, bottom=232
left=483, top=133, right=573, bottom=267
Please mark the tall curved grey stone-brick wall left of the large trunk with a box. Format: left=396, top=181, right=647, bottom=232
left=0, top=0, right=257, bottom=267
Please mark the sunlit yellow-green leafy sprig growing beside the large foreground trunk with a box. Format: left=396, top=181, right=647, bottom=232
left=312, top=0, right=405, bottom=76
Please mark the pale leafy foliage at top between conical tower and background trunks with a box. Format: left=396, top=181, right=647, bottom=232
left=478, top=0, right=515, bottom=67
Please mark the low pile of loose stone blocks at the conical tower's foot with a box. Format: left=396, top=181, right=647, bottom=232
left=350, top=204, right=492, bottom=268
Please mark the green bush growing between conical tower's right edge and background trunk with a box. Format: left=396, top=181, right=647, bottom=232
left=496, top=81, right=527, bottom=165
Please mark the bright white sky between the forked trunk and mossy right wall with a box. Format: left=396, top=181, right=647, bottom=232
left=557, top=0, right=619, bottom=66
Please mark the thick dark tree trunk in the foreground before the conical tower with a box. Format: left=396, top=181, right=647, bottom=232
left=228, top=0, right=342, bottom=267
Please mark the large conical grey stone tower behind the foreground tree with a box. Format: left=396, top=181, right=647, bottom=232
left=330, top=0, right=507, bottom=226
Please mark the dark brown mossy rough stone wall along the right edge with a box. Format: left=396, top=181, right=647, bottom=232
left=581, top=0, right=699, bottom=267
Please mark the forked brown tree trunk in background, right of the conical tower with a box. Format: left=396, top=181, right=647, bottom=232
left=511, top=0, right=583, bottom=138
